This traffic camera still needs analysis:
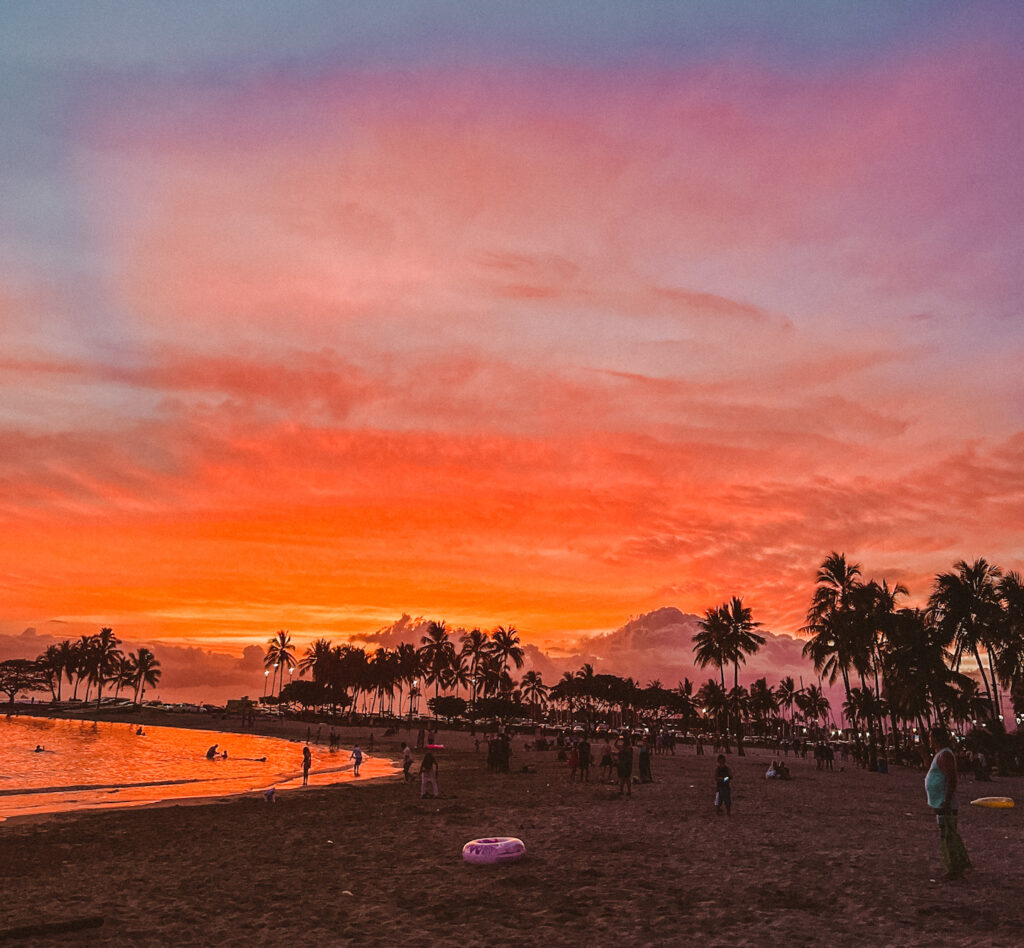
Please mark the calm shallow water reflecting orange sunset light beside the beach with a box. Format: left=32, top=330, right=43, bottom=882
left=0, top=717, right=395, bottom=820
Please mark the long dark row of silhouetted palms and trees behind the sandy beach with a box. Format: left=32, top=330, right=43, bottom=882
left=265, top=552, right=1024, bottom=765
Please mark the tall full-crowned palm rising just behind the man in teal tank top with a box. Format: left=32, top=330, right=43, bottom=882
left=928, top=559, right=1004, bottom=721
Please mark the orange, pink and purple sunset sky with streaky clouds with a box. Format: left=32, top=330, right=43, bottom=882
left=0, top=0, right=1024, bottom=696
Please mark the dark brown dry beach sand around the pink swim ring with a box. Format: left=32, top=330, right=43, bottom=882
left=0, top=720, right=1024, bottom=946
